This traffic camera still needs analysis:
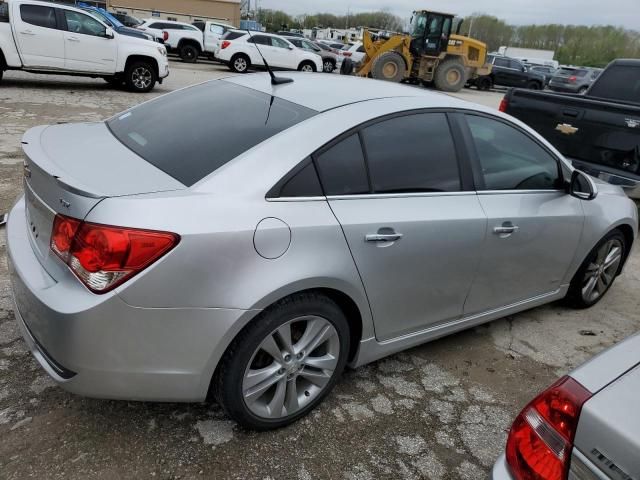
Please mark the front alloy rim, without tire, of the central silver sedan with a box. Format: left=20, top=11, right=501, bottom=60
left=582, top=238, right=623, bottom=302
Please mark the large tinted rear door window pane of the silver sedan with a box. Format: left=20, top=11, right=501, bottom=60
left=362, top=113, right=460, bottom=193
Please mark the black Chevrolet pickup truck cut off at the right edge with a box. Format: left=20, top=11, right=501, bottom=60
left=500, top=60, right=640, bottom=198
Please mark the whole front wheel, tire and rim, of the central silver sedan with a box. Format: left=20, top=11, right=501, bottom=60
left=567, top=230, right=627, bottom=308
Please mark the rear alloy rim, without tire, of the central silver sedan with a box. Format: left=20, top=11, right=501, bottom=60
left=242, top=316, right=340, bottom=419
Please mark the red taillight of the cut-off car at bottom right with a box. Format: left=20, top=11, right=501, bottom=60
left=506, top=377, right=592, bottom=480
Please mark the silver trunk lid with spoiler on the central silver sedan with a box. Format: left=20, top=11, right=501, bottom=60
left=22, top=123, right=186, bottom=278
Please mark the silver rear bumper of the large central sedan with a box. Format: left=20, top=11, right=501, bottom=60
left=7, top=195, right=255, bottom=402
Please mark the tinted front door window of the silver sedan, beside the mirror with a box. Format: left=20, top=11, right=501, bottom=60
left=467, top=115, right=560, bottom=190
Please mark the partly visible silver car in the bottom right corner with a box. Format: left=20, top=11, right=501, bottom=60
left=492, top=335, right=640, bottom=480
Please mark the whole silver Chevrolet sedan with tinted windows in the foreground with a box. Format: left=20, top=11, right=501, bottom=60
left=8, top=73, right=638, bottom=429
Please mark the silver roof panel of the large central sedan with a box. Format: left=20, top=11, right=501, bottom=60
left=223, top=72, right=471, bottom=112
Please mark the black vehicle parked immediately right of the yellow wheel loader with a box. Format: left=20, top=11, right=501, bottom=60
left=469, top=55, right=545, bottom=90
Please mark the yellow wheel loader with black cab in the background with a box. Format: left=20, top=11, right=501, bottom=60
left=342, top=10, right=491, bottom=92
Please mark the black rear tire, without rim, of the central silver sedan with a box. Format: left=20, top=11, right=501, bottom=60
left=212, top=293, right=350, bottom=431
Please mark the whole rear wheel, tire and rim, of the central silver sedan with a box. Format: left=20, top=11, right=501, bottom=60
left=218, top=293, right=349, bottom=430
